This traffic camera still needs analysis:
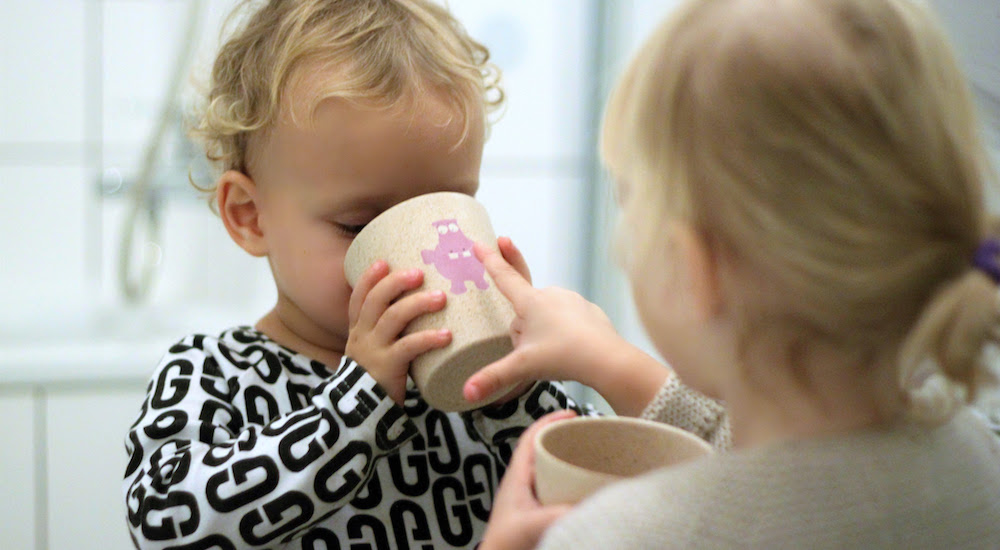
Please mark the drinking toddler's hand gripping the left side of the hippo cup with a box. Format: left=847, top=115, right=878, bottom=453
left=344, top=260, right=451, bottom=404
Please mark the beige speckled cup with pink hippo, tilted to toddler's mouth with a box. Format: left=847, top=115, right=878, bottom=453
left=344, top=192, right=514, bottom=411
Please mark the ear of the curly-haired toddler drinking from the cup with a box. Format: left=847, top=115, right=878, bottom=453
left=215, top=170, right=267, bottom=257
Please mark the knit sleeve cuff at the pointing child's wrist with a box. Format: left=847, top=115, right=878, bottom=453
left=639, top=376, right=732, bottom=450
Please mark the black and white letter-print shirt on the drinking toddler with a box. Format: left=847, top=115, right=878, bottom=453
left=124, top=327, right=593, bottom=550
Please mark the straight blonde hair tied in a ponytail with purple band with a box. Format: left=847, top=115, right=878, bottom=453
left=602, top=0, right=1000, bottom=418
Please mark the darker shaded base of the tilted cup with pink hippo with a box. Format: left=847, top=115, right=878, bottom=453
left=411, top=335, right=514, bottom=412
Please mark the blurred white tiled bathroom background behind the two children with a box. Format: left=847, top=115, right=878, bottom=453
left=0, top=0, right=1000, bottom=550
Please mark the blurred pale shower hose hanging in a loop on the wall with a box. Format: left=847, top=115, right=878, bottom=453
left=118, top=0, right=203, bottom=303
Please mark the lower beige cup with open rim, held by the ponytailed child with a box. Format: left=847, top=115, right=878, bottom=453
left=535, top=416, right=712, bottom=504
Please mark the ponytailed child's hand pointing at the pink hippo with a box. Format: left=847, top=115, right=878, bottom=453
left=463, top=244, right=670, bottom=415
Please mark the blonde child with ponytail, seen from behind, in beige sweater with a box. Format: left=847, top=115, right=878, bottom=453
left=467, top=0, right=1000, bottom=550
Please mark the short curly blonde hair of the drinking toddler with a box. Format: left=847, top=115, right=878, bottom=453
left=190, top=0, right=503, bottom=193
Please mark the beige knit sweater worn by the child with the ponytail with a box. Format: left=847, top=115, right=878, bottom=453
left=539, top=383, right=1000, bottom=550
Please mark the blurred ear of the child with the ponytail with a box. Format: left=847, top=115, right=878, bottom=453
left=672, top=223, right=723, bottom=321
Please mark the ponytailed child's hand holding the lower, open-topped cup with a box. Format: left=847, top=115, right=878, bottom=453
left=479, top=411, right=575, bottom=550
